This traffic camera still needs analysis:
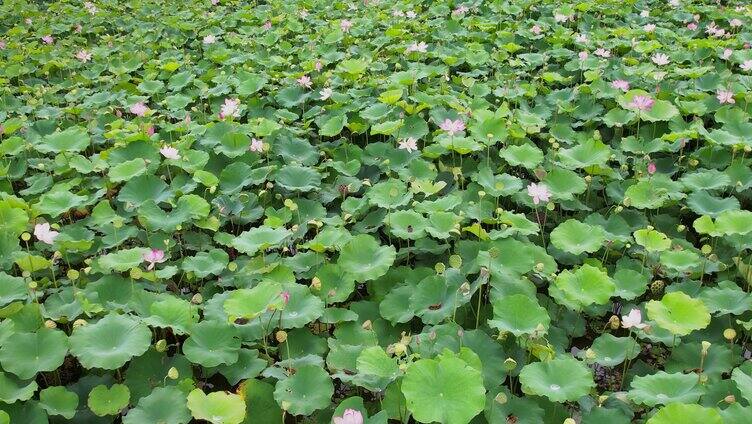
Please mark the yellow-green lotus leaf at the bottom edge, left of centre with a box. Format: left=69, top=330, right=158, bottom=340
left=187, top=389, right=245, bottom=424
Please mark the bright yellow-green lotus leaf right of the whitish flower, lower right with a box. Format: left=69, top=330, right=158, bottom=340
left=646, top=291, right=710, bottom=336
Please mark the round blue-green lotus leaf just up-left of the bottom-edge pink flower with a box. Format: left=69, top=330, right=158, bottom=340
left=274, top=365, right=334, bottom=415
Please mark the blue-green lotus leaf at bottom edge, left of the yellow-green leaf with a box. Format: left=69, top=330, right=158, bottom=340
left=123, top=387, right=191, bottom=424
